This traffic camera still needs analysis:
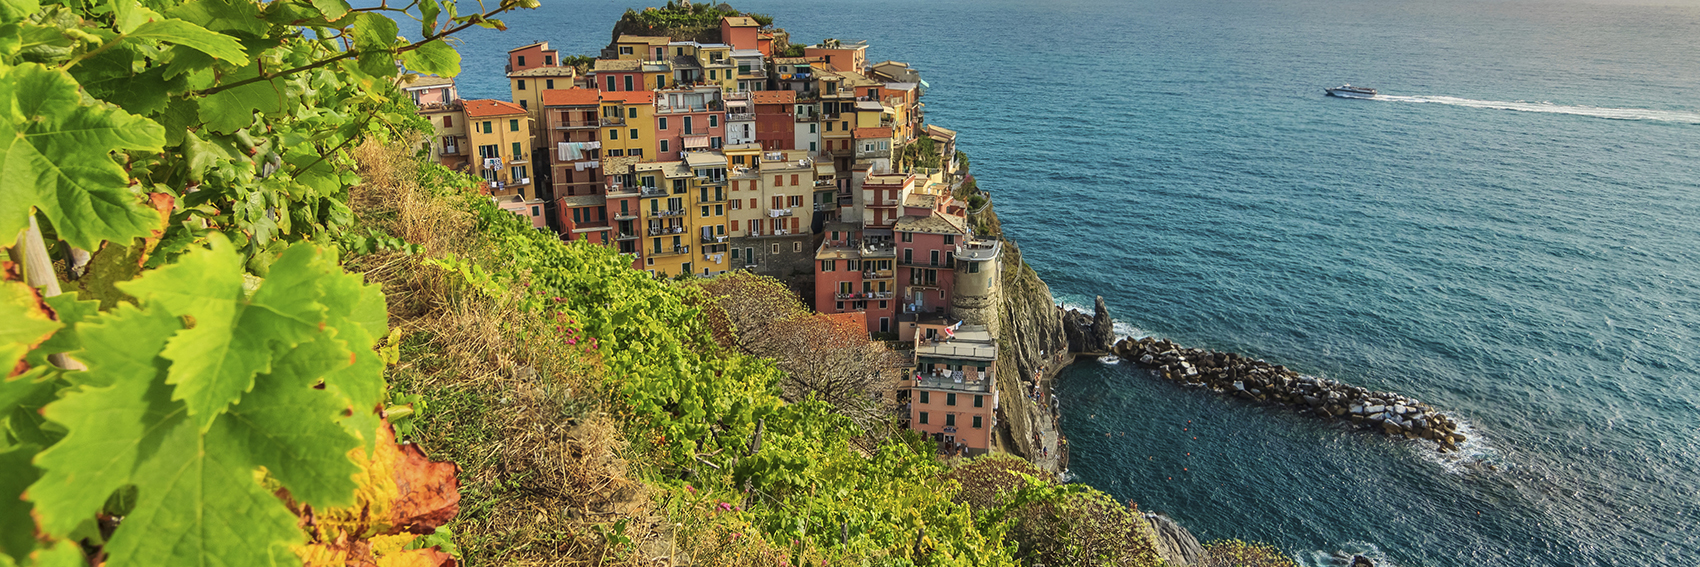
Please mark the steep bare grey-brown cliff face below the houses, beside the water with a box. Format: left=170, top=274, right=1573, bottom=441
left=998, top=239, right=1068, bottom=470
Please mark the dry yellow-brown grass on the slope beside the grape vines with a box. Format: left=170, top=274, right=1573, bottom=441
left=345, top=143, right=660, bottom=565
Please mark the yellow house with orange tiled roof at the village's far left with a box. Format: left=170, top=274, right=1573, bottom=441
left=462, top=98, right=537, bottom=199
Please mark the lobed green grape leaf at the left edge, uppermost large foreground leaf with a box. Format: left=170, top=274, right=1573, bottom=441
left=0, top=63, right=165, bottom=250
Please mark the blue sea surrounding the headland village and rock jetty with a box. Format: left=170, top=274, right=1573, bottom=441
left=428, top=0, right=1700, bottom=565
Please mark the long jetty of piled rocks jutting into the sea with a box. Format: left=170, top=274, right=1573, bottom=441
left=1112, top=336, right=1465, bottom=453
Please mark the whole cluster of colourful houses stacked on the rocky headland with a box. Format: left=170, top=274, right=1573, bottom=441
left=405, top=15, right=1001, bottom=453
